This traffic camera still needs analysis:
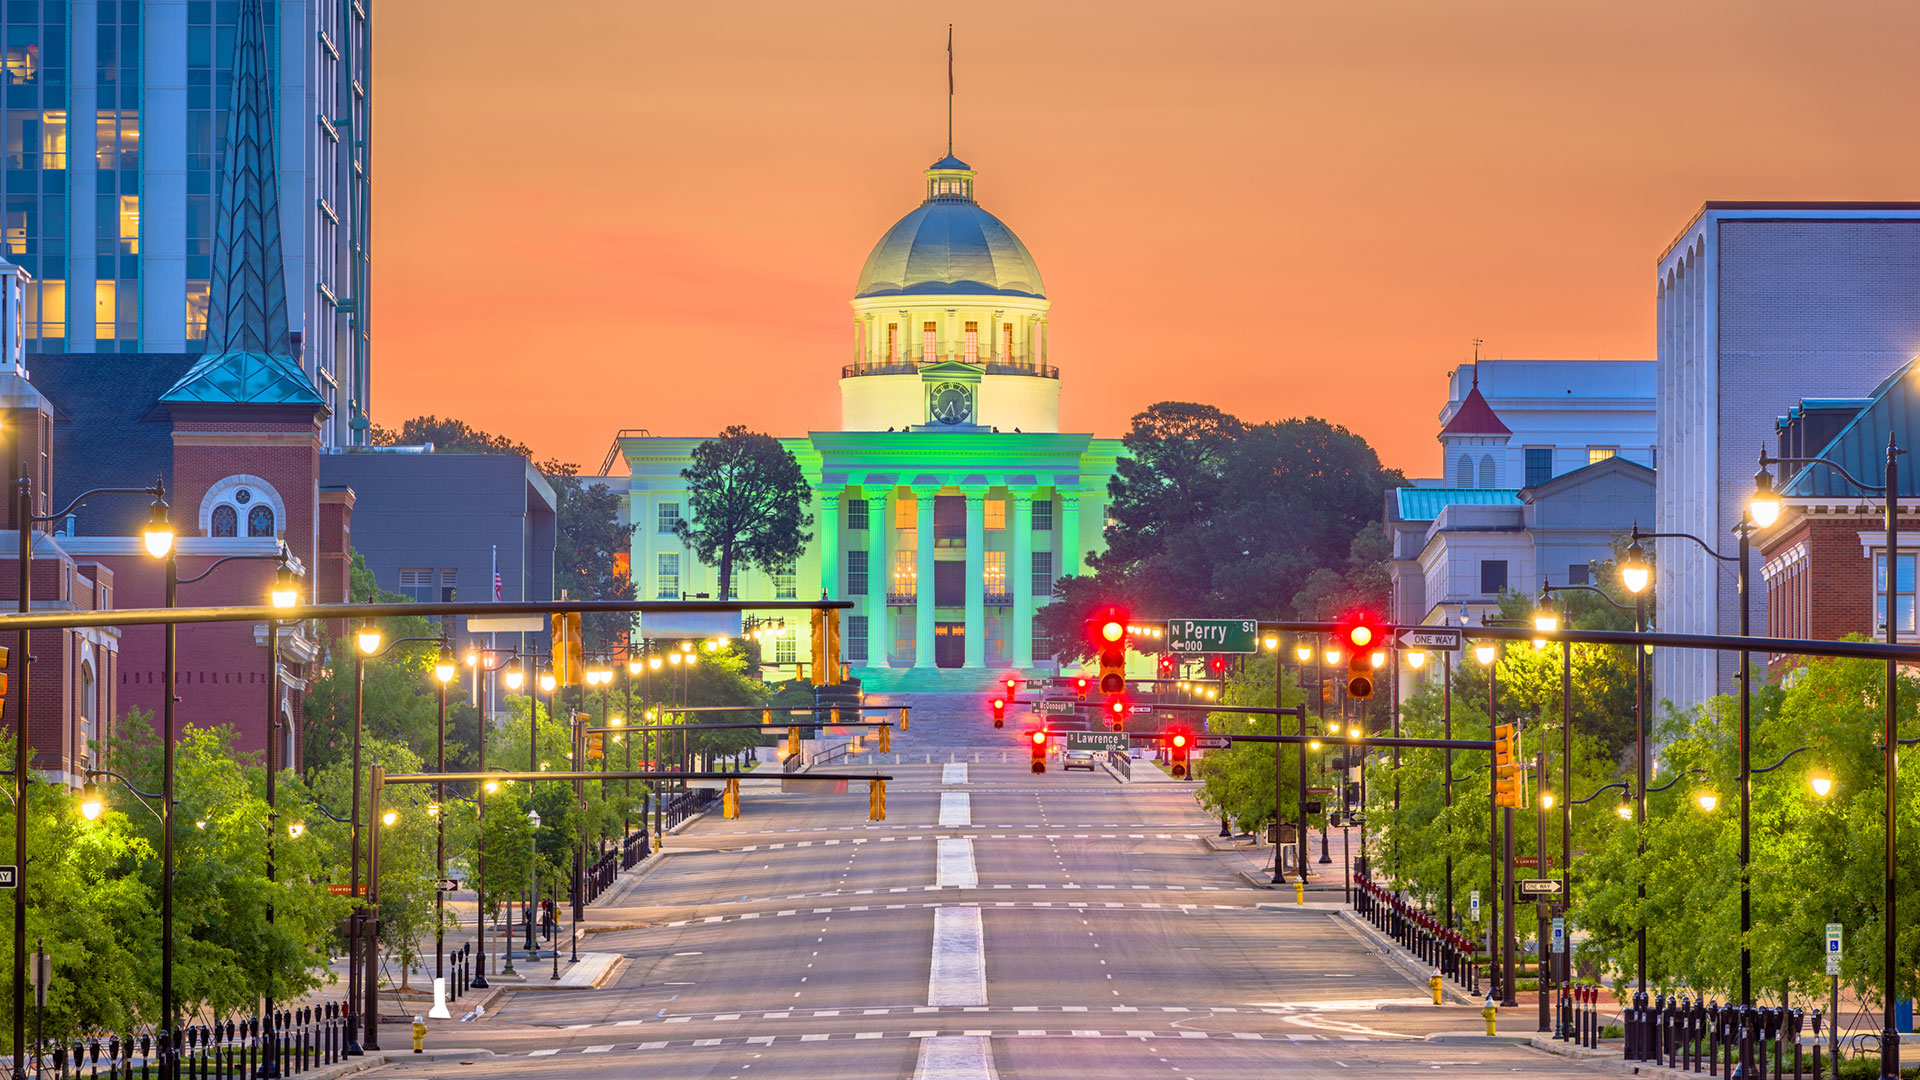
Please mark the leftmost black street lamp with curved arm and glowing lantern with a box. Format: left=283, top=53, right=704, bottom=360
left=13, top=477, right=173, bottom=1076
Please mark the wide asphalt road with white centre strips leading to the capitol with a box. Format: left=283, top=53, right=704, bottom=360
left=380, top=737, right=1609, bottom=1080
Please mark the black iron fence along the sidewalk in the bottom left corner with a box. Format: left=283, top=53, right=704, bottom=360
left=36, top=1001, right=346, bottom=1080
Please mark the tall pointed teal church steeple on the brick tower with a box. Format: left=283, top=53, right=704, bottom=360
left=161, top=0, right=324, bottom=405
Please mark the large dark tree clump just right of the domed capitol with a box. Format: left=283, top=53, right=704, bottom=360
left=1039, top=402, right=1405, bottom=659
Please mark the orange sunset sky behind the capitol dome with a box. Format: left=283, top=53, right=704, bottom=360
left=372, top=0, right=1920, bottom=475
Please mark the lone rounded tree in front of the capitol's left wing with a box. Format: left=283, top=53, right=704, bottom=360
left=674, top=425, right=814, bottom=600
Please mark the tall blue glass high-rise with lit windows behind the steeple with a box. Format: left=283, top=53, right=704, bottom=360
left=0, top=0, right=372, bottom=446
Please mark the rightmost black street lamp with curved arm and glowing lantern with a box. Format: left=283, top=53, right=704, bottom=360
left=1741, top=432, right=1907, bottom=1078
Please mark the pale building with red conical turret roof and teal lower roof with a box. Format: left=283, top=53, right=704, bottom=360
left=1386, top=359, right=1653, bottom=625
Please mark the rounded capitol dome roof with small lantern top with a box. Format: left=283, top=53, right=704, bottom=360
left=854, top=154, right=1046, bottom=300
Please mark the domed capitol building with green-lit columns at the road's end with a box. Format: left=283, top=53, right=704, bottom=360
left=616, top=156, right=1123, bottom=690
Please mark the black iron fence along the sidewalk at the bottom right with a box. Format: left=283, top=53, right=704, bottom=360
left=1624, top=994, right=1839, bottom=1080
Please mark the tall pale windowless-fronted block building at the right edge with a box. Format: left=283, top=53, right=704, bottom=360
left=1653, top=202, right=1920, bottom=705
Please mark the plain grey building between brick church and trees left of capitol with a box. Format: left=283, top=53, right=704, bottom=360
left=321, top=446, right=559, bottom=630
